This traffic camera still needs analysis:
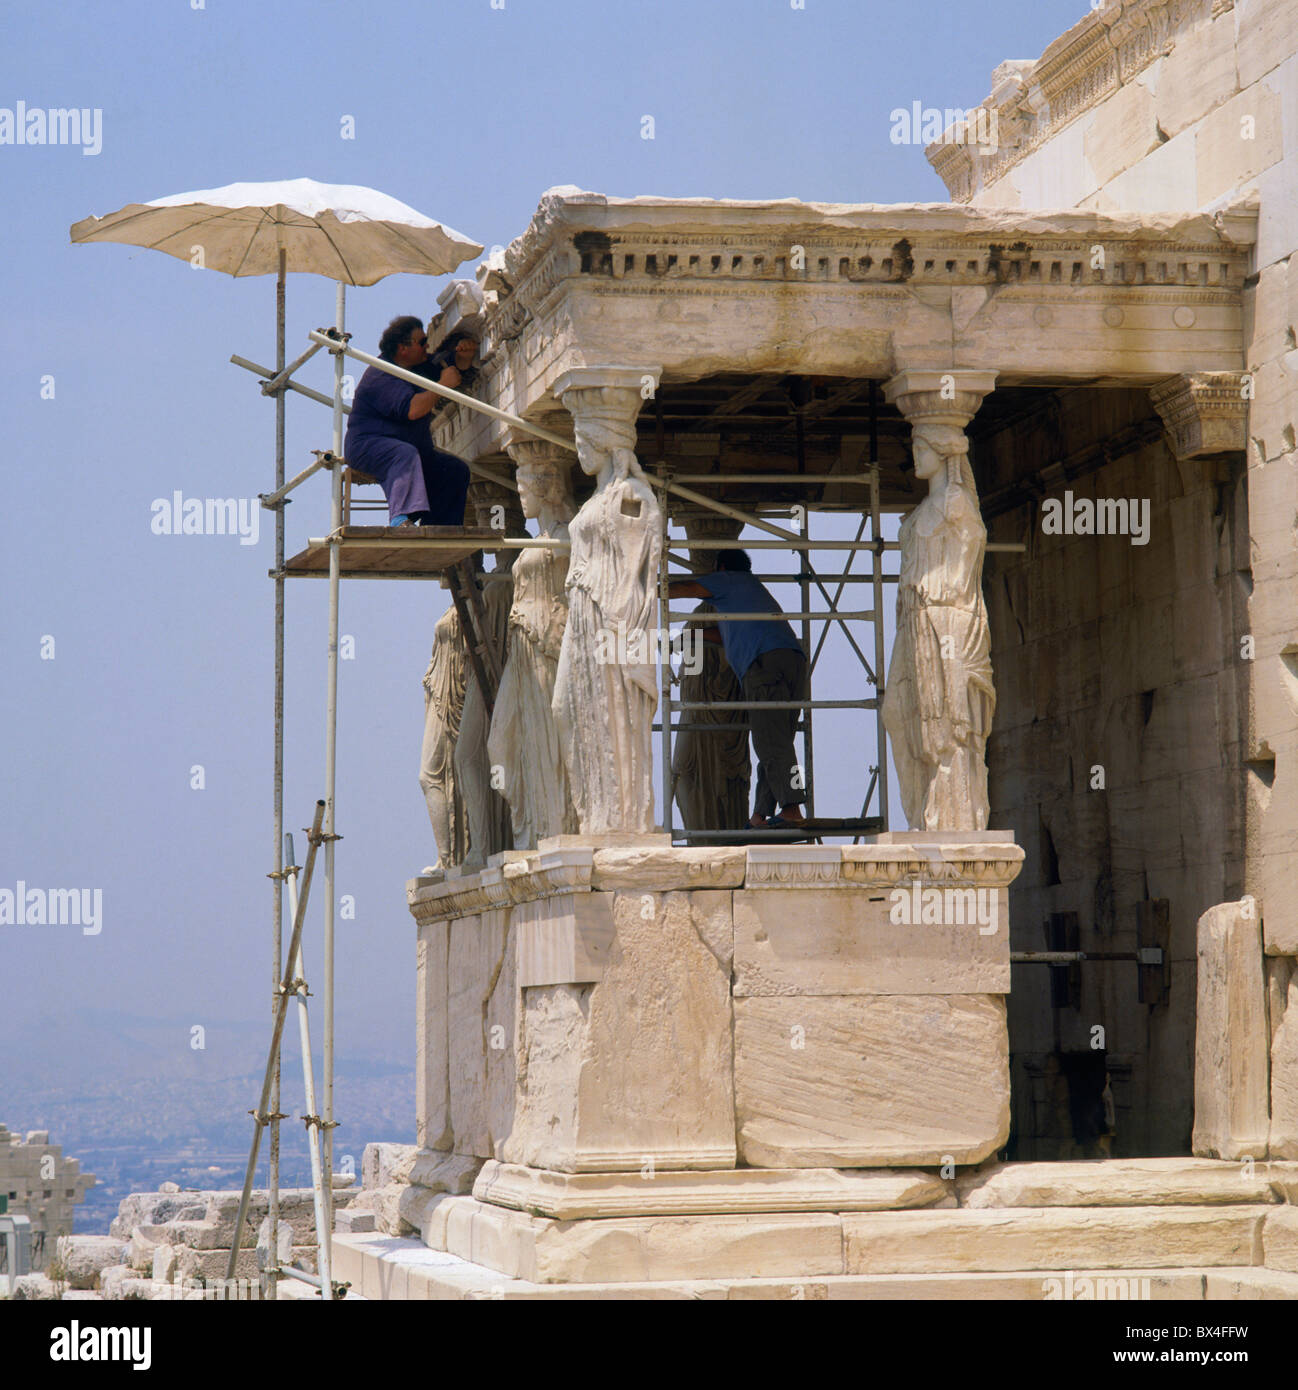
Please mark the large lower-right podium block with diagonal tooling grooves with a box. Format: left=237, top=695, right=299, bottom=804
left=735, top=994, right=1009, bottom=1168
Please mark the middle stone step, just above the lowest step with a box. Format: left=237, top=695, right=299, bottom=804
left=421, top=1197, right=1272, bottom=1283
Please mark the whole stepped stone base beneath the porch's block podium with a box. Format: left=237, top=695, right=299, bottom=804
left=335, top=1158, right=1298, bottom=1301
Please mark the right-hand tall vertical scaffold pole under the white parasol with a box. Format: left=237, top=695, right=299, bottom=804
left=321, top=281, right=347, bottom=1268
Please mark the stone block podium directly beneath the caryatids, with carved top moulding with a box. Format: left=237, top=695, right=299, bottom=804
left=407, top=831, right=1023, bottom=1175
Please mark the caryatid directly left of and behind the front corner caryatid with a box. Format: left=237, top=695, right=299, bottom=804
left=486, top=439, right=577, bottom=849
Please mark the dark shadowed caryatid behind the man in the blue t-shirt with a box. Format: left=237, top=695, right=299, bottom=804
left=671, top=516, right=752, bottom=830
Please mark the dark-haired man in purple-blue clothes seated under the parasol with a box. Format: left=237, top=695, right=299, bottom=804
left=343, top=314, right=477, bottom=525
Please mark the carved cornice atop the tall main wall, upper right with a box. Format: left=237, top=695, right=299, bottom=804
left=924, top=0, right=1234, bottom=203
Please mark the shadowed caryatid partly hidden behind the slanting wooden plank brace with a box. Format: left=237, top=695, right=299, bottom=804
left=454, top=482, right=527, bottom=870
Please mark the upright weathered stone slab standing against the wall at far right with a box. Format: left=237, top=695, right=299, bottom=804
left=1194, top=899, right=1270, bottom=1158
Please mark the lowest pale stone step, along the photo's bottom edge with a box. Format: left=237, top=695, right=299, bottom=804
left=334, top=1236, right=1298, bottom=1302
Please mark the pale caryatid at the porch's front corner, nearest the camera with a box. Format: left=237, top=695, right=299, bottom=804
left=552, top=367, right=663, bottom=834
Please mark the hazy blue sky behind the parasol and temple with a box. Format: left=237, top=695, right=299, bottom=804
left=0, top=0, right=1087, bottom=1095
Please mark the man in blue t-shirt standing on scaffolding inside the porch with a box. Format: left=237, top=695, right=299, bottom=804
left=667, top=550, right=809, bottom=828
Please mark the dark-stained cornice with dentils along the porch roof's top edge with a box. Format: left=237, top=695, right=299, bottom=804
left=482, top=201, right=1256, bottom=372
